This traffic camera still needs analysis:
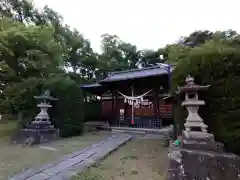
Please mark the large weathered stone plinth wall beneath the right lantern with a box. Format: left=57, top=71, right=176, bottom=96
left=168, top=145, right=240, bottom=180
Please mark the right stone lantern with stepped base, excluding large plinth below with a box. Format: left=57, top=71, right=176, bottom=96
left=179, top=75, right=222, bottom=150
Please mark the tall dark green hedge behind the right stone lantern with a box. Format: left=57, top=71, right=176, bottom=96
left=173, top=41, right=240, bottom=154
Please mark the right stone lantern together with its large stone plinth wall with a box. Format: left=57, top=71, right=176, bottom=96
left=167, top=76, right=240, bottom=180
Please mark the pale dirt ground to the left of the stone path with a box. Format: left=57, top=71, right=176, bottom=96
left=0, top=129, right=109, bottom=180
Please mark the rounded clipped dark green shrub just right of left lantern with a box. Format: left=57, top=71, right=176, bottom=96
left=45, top=76, right=84, bottom=137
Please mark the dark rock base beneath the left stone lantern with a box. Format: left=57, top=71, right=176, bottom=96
left=13, top=128, right=59, bottom=146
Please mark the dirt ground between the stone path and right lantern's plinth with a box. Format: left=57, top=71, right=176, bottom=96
left=73, top=140, right=168, bottom=180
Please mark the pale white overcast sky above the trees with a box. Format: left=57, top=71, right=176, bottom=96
left=33, top=0, right=240, bottom=52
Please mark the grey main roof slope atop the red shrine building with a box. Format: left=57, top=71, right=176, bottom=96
left=100, top=66, right=173, bottom=83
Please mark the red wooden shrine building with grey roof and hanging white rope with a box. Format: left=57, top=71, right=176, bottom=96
left=82, top=66, right=173, bottom=129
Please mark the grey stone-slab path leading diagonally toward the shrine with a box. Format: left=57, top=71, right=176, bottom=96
left=10, top=134, right=132, bottom=180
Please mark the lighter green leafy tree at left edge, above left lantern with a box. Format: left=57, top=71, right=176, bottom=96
left=0, top=18, right=61, bottom=112
